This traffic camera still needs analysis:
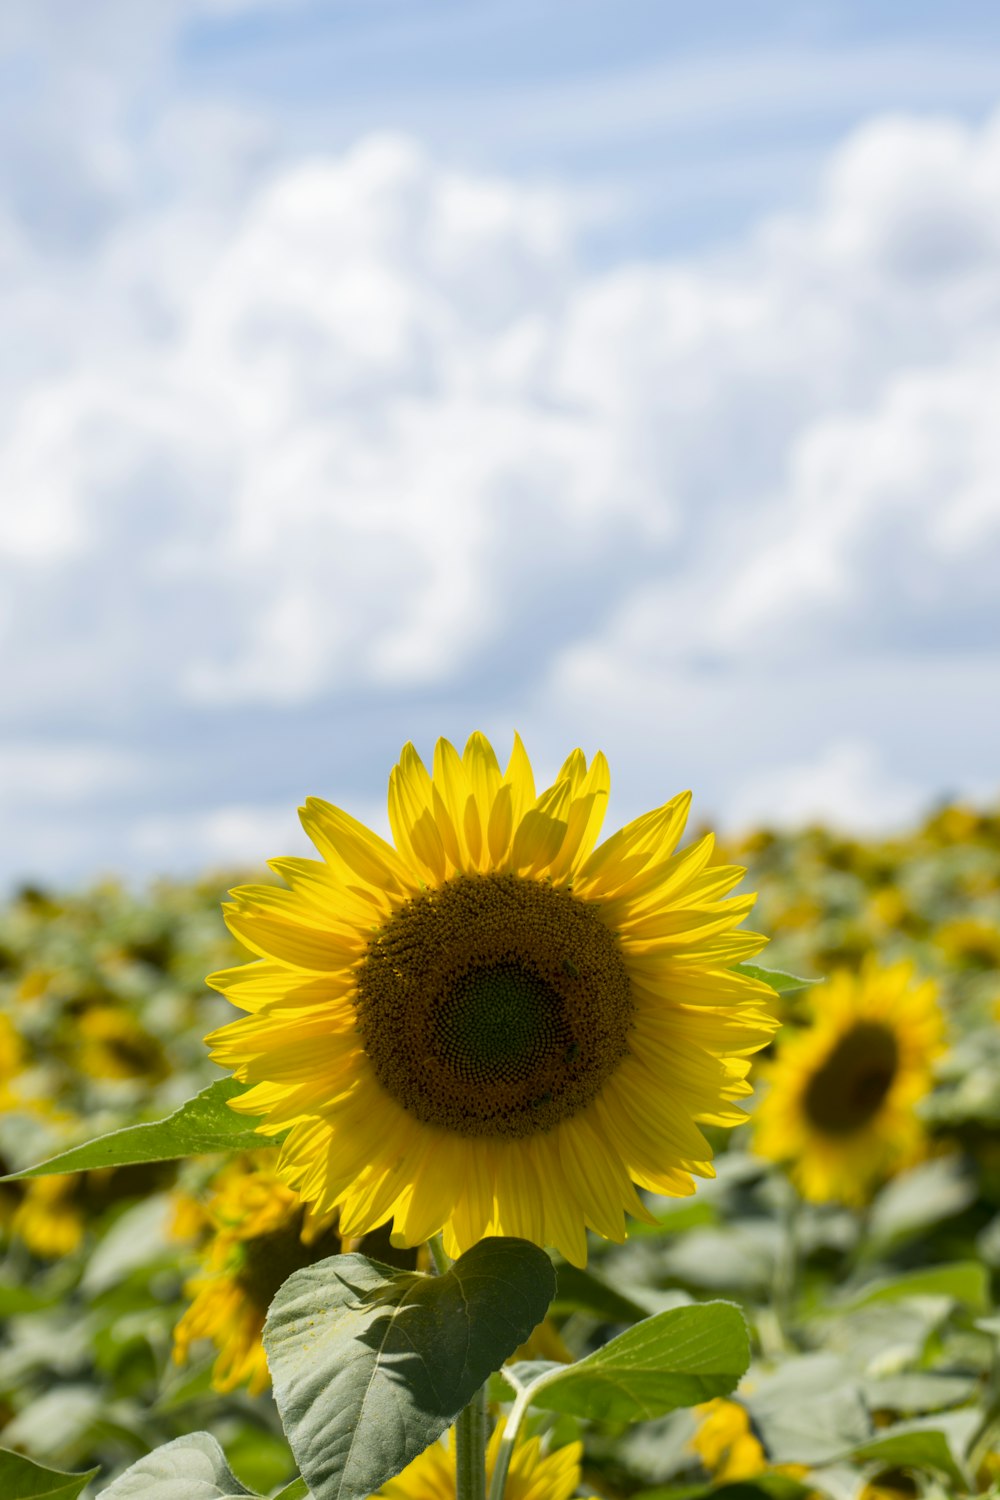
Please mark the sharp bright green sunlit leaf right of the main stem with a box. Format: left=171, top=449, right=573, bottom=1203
left=505, top=1302, right=750, bottom=1422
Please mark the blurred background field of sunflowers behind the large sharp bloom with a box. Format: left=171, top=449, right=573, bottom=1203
left=0, top=806, right=1000, bottom=1500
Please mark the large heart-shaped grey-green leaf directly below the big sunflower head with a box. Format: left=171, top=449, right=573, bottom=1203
left=264, top=1239, right=555, bottom=1500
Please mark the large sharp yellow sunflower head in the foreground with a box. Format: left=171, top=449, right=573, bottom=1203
left=208, top=734, right=777, bottom=1265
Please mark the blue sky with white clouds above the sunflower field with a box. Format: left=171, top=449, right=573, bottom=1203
left=0, top=0, right=1000, bottom=885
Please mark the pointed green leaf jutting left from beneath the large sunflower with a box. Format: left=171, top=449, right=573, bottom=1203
left=0, top=1079, right=276, bottom=1182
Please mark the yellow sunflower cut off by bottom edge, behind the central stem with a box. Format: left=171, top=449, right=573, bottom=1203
left=378, top=1427, right=583, bottom=1500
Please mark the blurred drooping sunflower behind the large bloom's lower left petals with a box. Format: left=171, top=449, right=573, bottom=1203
left=174, top=1152, right=340, bottom=1395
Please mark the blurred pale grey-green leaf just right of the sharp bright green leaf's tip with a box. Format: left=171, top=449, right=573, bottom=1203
left=741, top=1355, right=871, bottom=1464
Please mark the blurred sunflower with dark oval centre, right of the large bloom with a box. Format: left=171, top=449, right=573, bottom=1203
left=754, top=960, right=943, bottom=1206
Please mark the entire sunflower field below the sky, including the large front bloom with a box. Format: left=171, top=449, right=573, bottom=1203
left=0, top=750, right=1000, bottom=1500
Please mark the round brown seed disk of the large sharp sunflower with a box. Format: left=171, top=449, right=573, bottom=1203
left=358, top=875, right=633, bottom=1137
